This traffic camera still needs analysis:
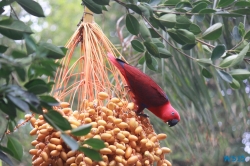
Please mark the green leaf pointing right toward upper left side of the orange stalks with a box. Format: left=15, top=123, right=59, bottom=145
left=39, top=42, right=65, bottom=59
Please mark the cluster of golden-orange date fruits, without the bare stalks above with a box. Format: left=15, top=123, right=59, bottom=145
left=26, top=92, right=171, bottom=166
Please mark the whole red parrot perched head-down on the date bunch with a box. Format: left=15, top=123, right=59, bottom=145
left=108, top=53, right=180, bottom=127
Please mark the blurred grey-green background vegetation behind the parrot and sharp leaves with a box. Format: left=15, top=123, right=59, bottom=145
left=0, top=0, right=250, bottom=166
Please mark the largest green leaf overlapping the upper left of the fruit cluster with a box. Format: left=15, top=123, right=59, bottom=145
left=44, top=110, right=72, bottom=131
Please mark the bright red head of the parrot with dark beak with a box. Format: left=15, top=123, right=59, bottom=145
left=162, top=102, right=180, bottom=127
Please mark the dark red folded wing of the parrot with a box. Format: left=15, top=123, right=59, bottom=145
left=120, top=62, right=168, bottom=107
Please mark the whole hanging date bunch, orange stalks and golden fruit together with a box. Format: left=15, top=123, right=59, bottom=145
left=26, top=7, right=171, bottom=166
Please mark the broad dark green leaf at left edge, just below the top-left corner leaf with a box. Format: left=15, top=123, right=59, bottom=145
left=0, top=19, right=33, bottom=40
